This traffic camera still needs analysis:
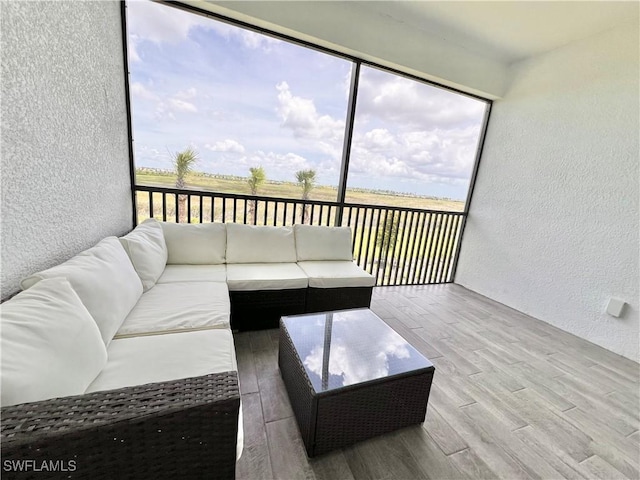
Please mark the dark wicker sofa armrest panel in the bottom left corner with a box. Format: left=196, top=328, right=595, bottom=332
left=1, top=372, right=240, bottom=480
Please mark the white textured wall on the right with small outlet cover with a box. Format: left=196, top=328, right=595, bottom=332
left=455, top=19, right=640, bottom=361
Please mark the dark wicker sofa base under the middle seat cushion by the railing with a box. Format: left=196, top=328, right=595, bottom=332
left=229, top=288, right=307, bottom=330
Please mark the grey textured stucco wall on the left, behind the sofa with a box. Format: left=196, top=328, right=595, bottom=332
left=0, top=1, right=132, bottom=298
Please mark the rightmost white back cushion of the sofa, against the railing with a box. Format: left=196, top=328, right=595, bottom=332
left=293, top=225, right=353, bottom=262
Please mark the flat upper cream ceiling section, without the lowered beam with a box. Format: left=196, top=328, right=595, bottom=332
left=354, top=1, right=639, bottom=63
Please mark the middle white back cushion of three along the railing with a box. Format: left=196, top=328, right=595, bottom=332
left=227, top=223, right=297, bottom=264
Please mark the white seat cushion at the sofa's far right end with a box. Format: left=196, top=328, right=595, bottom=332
left=298, top=261, right=376, bottom=288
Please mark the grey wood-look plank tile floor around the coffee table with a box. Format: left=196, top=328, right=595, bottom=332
left=235, top=285, right=640, bottom=480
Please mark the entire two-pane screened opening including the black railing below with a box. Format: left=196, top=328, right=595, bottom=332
left=126, top=1, right=490, bottom=285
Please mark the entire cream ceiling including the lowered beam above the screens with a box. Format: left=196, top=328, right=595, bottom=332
left=192, top=0, right=640, bottom=99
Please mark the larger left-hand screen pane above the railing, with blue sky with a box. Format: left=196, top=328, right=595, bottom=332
left=127, top=2, right=352, bottom=201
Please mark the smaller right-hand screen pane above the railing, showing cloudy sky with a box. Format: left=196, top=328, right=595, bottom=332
left=346, top=66, right=487, bottom=211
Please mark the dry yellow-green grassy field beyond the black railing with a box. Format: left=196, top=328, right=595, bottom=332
left=136, top=172, right=464, bottom=285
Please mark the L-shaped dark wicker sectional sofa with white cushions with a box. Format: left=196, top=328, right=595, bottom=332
left=1, top=220, right=375, bottom=478
